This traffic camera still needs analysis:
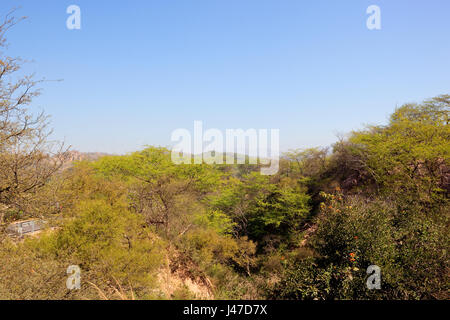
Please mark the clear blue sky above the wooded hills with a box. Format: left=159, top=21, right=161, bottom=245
left=0, top=0, right=450, bottom=153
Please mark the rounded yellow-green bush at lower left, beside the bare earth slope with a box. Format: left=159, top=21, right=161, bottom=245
left=26, top=200, right=164, bottom=297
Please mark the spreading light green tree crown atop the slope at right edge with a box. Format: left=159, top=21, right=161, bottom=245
left=342, top=96, right=450, bottom=203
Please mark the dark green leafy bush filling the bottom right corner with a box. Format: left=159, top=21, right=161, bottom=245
left=274, top=194, right=449, bottom=299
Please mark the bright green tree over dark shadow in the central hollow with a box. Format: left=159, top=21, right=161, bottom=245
left=208, top=173, right=310, bottom=246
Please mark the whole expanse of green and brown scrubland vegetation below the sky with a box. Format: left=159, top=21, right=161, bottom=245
left=0, top=15, right=450, bottom=300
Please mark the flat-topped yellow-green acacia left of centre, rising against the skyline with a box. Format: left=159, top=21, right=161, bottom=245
left=94, top=147, right=221, bottom=238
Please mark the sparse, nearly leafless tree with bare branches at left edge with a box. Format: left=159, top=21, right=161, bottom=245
left=0, top=13, right=66, bottom=225
